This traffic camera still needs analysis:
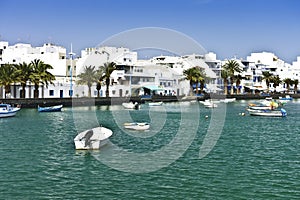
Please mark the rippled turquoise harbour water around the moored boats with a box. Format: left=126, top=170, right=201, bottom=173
left=0, top=101, right=300, bottom=199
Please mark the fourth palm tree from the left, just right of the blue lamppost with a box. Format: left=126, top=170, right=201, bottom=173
left=77, top=65, right=99, bottom=97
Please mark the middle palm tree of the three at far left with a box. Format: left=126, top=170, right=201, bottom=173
left=15, top=62, right=33, bottom=98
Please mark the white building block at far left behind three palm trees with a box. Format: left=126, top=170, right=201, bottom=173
left=0, top=41, right=76, bottom=98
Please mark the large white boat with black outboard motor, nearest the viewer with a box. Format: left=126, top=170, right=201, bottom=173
left=74, top=126, right=113, bottom=150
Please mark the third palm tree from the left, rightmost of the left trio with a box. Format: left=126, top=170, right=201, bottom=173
left=30, top=59, right=55, bottom=98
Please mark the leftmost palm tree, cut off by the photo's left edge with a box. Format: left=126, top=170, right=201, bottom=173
left=0, top=64, right=16, bottom=98
